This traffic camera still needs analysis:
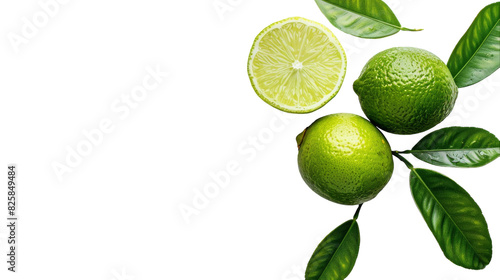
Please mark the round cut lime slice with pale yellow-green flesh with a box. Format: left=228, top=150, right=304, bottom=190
left=248, top=17, right=346, bottom=113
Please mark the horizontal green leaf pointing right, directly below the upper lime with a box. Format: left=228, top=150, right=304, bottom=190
left=401, top=127, right=500, bottom=167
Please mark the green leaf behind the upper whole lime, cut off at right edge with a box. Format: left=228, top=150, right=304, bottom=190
left=448, top=2, right=500, bottom=88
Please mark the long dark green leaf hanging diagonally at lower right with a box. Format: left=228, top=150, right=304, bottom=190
left=410, top=169, right=492, bottom=269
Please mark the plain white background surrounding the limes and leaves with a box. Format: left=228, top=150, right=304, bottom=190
left=0, top=0, right=500, bottom=280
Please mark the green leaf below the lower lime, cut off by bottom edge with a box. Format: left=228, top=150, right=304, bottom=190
left=306, top=219, right=360, bottom=280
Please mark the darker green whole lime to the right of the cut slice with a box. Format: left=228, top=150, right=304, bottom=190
left=354, top=47, right=458, bottom=134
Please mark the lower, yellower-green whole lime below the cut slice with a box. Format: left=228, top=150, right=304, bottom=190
left=296, top=114, right=394, bottom=205
